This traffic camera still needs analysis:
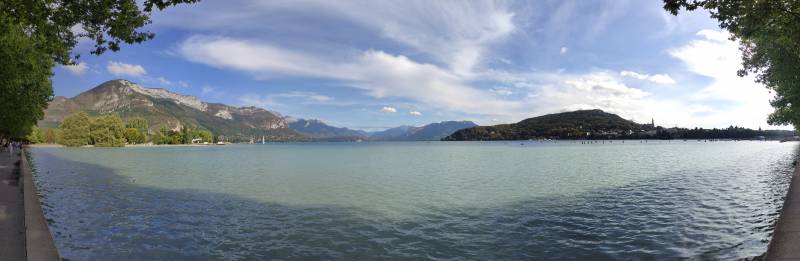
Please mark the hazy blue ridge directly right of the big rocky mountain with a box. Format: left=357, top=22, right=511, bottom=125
left=286, top=118, right=367, bottom=141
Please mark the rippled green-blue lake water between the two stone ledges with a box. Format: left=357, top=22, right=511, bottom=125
left=31, top=141, right=797, bottom=260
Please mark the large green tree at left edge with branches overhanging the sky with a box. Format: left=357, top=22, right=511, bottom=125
left=0, top=0, right=197, bottom=142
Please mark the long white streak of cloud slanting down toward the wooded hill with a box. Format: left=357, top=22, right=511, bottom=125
left=179, top=36, right=520, bottom=113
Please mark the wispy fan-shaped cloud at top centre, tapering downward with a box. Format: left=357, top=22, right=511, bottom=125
left=323, top=1, right=514, bottom=75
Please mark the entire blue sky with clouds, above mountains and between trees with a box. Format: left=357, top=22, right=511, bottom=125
left=53, top=0, right=787, bottom=130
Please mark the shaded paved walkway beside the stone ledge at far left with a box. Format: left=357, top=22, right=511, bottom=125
left=0, top=148, right=25, bottom=261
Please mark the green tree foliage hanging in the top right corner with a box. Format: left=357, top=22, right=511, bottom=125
left=664, top=0, right=800, bottom=128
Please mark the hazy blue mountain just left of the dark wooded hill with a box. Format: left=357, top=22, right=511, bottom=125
left=369, top=121, right=478, bottom=141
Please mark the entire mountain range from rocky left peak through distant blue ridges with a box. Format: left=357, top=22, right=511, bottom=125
left=39, top=80, right=477, bottom=141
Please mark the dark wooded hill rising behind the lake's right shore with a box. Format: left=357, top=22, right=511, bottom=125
left=445, top=110, right=654, bottom=140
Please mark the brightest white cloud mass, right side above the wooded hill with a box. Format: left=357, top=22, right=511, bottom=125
left=476, top=30, right=773, bottom=128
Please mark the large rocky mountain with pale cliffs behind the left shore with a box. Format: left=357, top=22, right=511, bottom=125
left=39, top=80, right=308, bottom=141
